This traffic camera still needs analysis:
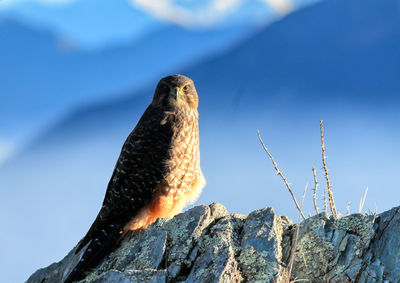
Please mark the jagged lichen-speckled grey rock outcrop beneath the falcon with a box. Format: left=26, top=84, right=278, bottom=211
left=27, top=204, right=400, bottom=283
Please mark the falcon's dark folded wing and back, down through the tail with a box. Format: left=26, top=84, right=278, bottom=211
left=65, top=105, right=172, bottom=283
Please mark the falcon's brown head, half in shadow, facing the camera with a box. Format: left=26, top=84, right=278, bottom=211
left=152, top=75, right=199, bottom=110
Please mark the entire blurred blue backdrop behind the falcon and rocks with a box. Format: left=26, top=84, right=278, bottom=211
left=0, top=0, right=400, bottom=282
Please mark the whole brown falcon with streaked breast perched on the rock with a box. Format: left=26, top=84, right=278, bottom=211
left=64, top=75, right=205, bottom=283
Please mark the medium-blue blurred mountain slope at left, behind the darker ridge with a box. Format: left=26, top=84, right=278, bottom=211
left=0, top=21, right=248, bottom=143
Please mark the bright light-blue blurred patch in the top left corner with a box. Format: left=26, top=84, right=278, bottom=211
left=0, top=0, right=159, bottom=50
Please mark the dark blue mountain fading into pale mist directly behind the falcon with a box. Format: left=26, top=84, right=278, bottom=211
left=0, top=0, right=400, bottom=282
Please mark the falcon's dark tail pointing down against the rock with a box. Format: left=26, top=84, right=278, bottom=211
left=64, top=224, right=121, bottom=283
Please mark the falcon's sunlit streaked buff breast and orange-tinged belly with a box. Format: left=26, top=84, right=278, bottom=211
left=125, top=112, right=205, bottom=234
